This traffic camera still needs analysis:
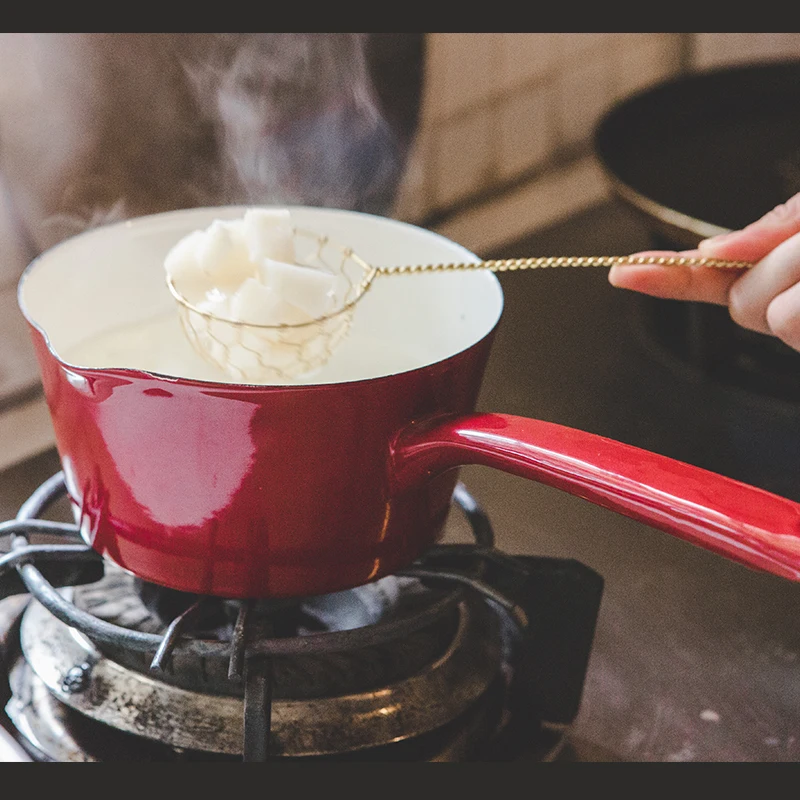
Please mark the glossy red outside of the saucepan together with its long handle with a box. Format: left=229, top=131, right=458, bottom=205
left=21, top=209, right=800, bottom=598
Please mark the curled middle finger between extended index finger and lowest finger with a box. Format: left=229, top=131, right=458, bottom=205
left=728, top=228, right=800, bottom=338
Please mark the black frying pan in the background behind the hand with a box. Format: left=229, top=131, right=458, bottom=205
left=595, top=60, right=800, bottom=247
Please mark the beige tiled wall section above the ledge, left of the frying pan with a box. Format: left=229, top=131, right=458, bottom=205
left=396, top=33, right=681, bottom=228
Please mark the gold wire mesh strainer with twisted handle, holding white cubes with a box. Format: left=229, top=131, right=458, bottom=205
left=167, top=228, right=753, bottom=383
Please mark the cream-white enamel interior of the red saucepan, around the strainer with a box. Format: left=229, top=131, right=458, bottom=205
left=19, top=207, right=503, bottom=384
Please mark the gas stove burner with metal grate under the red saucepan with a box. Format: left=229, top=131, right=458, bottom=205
left=0, top=473, right=603, bottom=762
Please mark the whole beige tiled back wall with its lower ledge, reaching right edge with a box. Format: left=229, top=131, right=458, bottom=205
left=395, top=33, right=800, bottom=250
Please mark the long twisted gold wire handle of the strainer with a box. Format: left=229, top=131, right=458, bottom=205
left=375, top=256, right=753, bottom=275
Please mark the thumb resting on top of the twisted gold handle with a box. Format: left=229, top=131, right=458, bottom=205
left=698, top=193, right=800, bottom=262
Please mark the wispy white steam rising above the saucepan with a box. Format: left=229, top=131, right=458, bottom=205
left=186, top=33, right=399, bottom=211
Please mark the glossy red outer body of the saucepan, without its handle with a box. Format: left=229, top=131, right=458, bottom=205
left=33, top=330, right=500, bottom=597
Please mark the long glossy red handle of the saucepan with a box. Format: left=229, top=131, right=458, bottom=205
left=394, top=414, right=800, bottom=581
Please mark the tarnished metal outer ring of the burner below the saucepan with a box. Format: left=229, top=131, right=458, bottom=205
left=9, top=580, right=501, bottom=756
